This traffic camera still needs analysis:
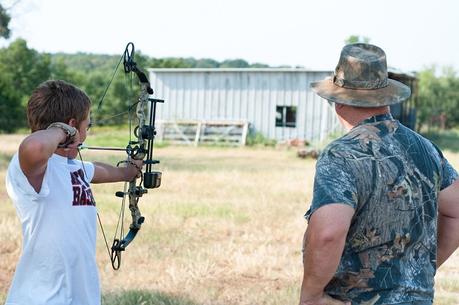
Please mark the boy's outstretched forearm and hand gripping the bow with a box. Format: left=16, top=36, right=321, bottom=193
left=91, top=160, right=143, bottom=183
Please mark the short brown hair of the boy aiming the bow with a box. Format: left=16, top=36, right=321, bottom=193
left=27, top=80, right=91, bottom=132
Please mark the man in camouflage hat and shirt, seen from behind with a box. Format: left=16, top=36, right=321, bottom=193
left=300, top=43, right=459, bottom=305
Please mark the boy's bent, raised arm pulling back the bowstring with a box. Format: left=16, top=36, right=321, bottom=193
left=18, top=128, right=71, bottom=192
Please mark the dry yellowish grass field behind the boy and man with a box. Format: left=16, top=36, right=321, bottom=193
left=0, top=129, right=459, bottom=305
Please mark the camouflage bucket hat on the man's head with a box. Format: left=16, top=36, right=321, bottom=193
left=311, top=43, right=411, bottom=108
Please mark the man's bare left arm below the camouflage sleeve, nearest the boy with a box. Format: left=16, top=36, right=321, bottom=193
left=300, top=203, right=354, bottom=305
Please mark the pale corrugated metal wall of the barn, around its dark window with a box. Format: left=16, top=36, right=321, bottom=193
left=150, top=69, right=339, bottom=141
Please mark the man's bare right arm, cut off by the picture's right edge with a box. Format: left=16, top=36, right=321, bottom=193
left=437, top=180, right=459, bottom=268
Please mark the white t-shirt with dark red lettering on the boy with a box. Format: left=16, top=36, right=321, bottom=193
left=5, top=154, right=101, bottom=305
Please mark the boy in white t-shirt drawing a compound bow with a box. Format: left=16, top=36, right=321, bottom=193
left=6, top=81, right=142, bottom=305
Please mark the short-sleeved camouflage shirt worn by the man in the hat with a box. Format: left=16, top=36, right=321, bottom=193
left=306, top=114, right=457, bottom=304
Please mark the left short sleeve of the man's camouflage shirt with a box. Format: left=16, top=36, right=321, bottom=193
left=305, top=151, right=357, bottom=221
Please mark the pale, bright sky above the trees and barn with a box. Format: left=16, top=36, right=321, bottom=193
left=0, top=0, right=459, bottom=72
